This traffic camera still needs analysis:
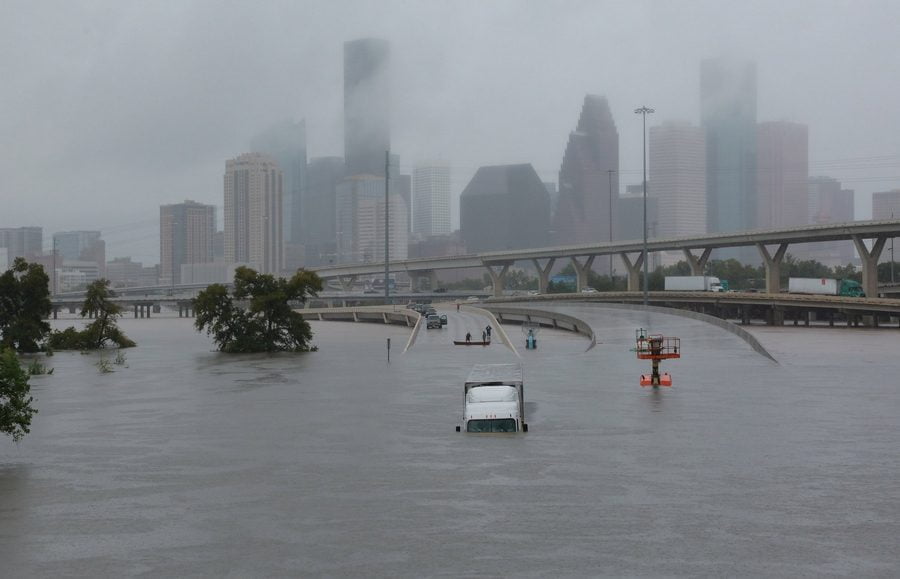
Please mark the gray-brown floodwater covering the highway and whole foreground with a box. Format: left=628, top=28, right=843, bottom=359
left=0, top=305, right=900, bottom=578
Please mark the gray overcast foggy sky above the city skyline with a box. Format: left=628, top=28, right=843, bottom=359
left=0, top=0, right=900, bottom=265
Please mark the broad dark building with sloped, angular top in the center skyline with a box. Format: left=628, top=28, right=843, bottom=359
left=459, top=164, right=550, bottom=253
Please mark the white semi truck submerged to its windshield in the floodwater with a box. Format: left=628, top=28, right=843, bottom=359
left=456, top=364, right=528, bottom=432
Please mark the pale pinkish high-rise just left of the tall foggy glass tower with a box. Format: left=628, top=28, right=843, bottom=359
left=642, top=122, right=706, bottom=239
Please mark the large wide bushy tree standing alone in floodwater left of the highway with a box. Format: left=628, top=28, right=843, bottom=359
left=194, top=267, right=322, bottom=353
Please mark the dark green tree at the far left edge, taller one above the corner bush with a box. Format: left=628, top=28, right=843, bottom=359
left=0, top=257, right=52, bottom=352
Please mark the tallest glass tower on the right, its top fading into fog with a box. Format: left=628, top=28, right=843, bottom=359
left=700, top=59, right=757, bottom=238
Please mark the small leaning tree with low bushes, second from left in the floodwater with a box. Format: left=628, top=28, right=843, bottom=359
left=48, top=279, right=137, bottom=350
